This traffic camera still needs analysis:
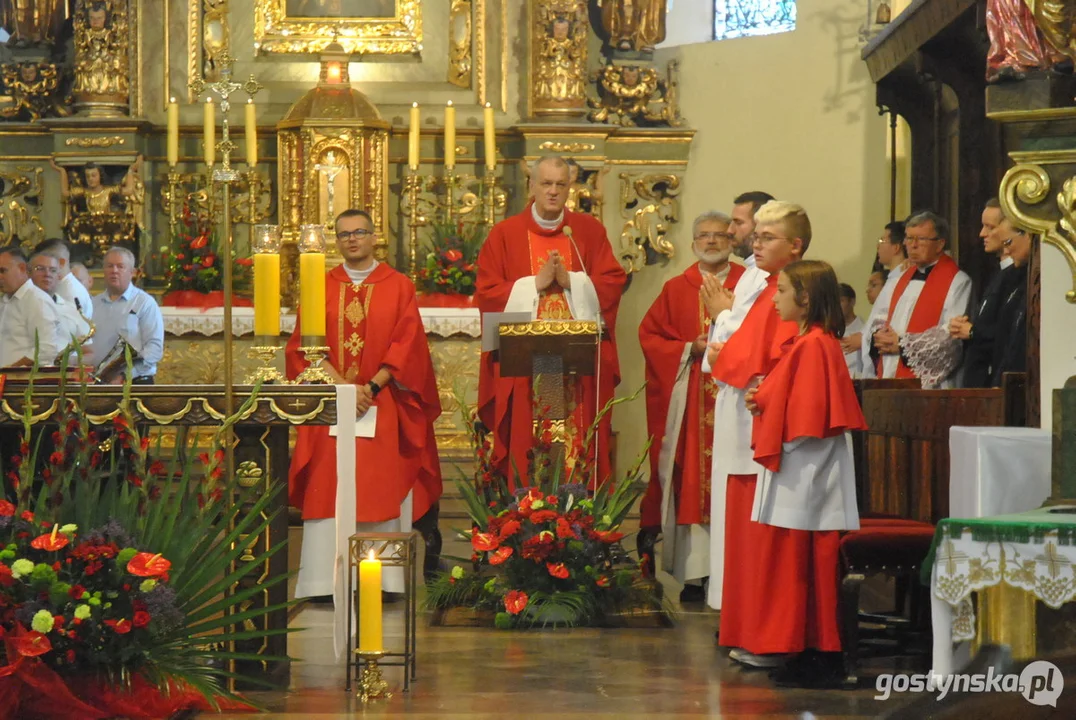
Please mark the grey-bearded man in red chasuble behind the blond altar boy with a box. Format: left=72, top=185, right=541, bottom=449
left=639, top=212, right=744, bottom=603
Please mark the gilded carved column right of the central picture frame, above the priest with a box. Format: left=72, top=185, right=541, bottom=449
left=528, top=0, right=591, bottom=118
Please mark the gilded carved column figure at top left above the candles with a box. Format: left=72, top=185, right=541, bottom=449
left=73, top=0, right=130, bottom=115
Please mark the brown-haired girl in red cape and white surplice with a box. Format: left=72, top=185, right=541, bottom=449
left=748, top=260, right=866, bottom=686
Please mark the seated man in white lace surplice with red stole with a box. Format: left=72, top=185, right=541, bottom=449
left=870, top=212, right=972, bottom=389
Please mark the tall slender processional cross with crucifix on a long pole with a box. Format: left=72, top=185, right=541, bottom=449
left=190, top=54, right=261, bottom=477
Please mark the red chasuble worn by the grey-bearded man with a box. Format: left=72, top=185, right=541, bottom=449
left=639, top=263, right=744, bottom=527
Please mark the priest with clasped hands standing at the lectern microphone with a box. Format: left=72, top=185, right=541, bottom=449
left=475, top=156, right=626, bottom=482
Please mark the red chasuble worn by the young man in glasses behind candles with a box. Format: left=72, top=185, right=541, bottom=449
left=286, top=263, right=441, bottom=522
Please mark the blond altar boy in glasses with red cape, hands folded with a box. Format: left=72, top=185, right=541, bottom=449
left=707, top=200, right=811, bottom=666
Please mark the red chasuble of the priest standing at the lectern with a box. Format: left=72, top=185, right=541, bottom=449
left=475, top=204, right=626, bottom=479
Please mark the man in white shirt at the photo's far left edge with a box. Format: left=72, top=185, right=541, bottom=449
left=0, top=246, right=62, bottom=367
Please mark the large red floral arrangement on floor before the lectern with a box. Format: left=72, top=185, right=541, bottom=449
left=427, top=389, right=666, bottom=629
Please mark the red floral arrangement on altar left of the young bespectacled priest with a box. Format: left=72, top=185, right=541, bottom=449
left=161, top=203, right=254, bottom=294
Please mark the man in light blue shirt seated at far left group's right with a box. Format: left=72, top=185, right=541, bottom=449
left=94, top=248, right=165, bottom=385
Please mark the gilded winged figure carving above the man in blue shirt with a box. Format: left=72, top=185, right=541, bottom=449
left=49, top=155, right=145, bottom=265
